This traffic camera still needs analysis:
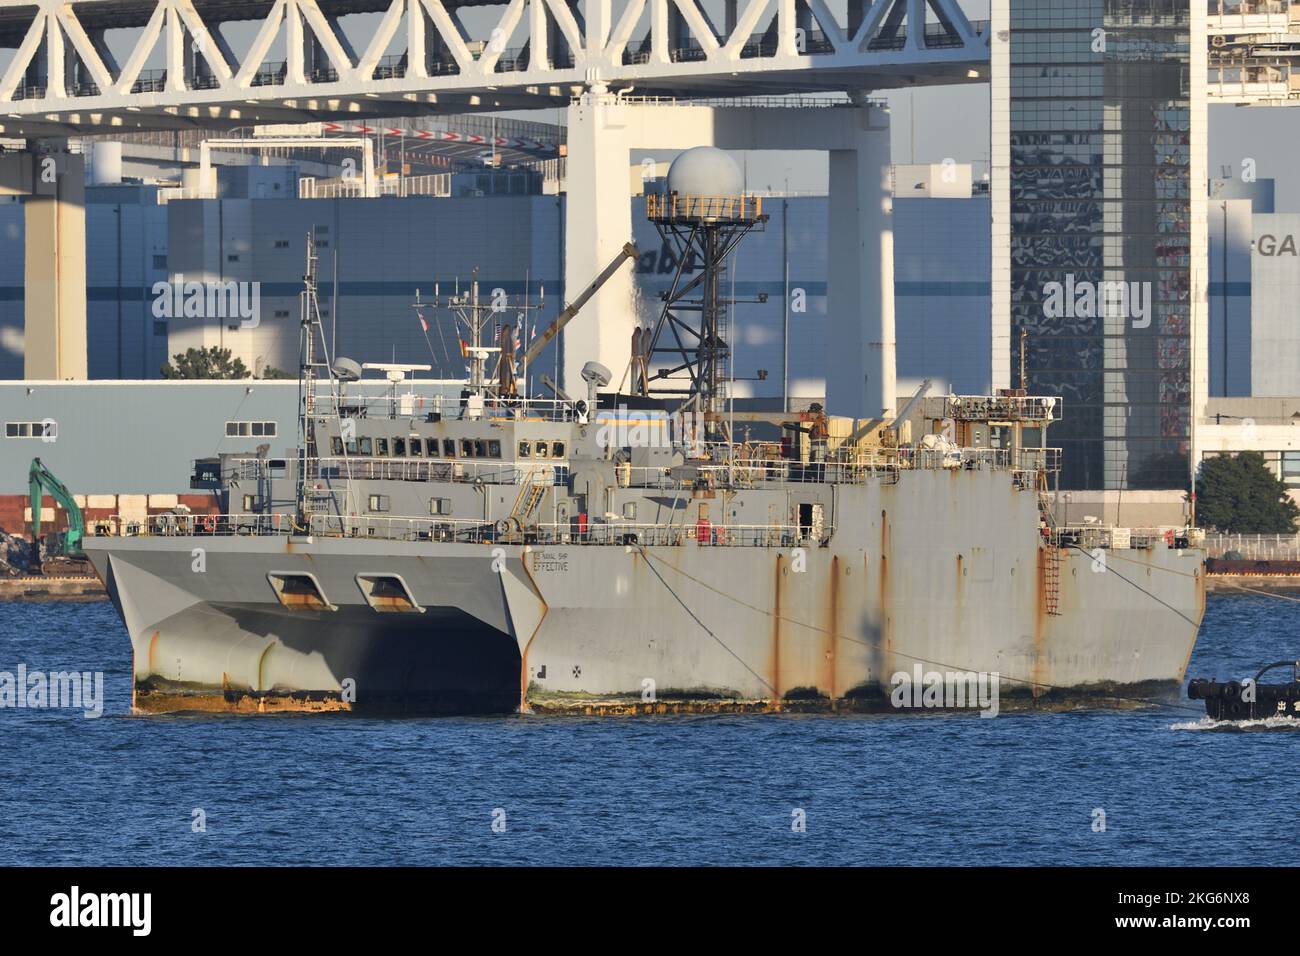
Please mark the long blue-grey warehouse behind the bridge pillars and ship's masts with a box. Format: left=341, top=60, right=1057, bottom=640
left=0, top=153, right=989, bottom=403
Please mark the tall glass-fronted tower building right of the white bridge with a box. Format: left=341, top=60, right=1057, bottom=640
left=995, top=0, right=1205, bottom=489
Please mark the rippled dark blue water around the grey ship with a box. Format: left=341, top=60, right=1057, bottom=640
left=0, top=597, right=1300, bottom=865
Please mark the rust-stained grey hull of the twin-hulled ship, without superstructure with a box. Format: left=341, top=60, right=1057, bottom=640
left=86, top=471, right=1205, bottom=713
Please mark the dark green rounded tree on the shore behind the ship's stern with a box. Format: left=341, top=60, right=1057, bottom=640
left=1196, top=451, right=1300, bottom=535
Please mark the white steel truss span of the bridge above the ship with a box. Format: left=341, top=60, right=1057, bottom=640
left=0, top=0, right=988, bottom=138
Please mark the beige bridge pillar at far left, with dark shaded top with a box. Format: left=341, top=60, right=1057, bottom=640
left=0, top=151, right=86, bottom=378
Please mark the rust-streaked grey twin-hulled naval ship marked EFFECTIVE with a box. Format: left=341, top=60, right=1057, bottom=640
left=85, top=151, right=1205, bottom=713
